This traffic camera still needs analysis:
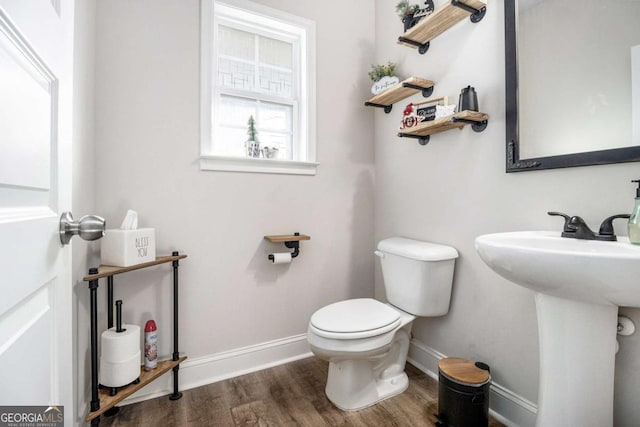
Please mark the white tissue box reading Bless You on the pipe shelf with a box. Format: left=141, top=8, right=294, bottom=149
left=101, top=228, right=156, bottom=267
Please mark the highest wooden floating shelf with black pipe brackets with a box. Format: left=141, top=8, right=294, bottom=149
left=398, top=0, right=487, bottom=54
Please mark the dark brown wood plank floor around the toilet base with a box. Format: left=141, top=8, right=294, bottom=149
left=100, top=357, right=502, bottom=427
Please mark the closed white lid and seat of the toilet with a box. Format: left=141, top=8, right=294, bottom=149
left=309, top=298, right=400, bottom=340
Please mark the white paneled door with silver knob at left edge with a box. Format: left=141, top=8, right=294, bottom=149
left=0, top=0, right=75, bottom=425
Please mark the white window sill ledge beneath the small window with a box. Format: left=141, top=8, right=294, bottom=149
left=200, top=155, right=319, bottom=175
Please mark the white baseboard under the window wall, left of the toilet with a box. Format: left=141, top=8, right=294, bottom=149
left=122, top=334, right=312, bottom=405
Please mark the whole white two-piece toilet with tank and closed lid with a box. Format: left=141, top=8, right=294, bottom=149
left=307, top=237, right=458, bottom=411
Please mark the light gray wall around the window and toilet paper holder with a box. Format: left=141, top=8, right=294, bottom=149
left=95, top=0, right=374, bottom=372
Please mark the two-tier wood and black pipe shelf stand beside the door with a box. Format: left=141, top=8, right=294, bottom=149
left=83, top=252, right=187, bottom=426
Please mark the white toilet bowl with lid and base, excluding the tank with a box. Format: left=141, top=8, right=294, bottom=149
left=307, top=298, right=415, bottom=410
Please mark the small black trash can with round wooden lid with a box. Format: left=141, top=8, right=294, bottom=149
left=436, top=357, right=491, bottom=427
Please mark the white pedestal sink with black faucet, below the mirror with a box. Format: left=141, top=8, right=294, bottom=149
left=476, top=231, right=640, bottom=427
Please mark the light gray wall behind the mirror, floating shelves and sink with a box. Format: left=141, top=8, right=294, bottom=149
left=375, top=0, right=640, bottom=426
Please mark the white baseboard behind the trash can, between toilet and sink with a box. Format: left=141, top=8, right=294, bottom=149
left=408, top=339, right=538, bottom=427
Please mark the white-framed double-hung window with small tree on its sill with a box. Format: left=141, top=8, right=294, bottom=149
left=200, top=0, right=317, bottom=175
